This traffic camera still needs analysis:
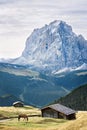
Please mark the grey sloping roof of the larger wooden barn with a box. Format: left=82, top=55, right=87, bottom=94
left=42, top=104, right=76, bottom=115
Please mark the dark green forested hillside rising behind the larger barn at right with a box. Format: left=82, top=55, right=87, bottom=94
left=56, top=84, right=87, bottom=111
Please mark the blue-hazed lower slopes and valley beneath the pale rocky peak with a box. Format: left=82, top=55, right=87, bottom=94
left=0, top=63, right=87, bottom=107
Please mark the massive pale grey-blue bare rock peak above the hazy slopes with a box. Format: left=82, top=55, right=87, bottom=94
left=11, top=20, right=87, bottom=73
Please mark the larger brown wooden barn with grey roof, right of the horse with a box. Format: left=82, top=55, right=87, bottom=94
left=41, top=104, right=76, bottom=120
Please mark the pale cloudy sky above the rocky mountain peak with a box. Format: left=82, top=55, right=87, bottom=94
left=0, top=0, right=87, bottom=58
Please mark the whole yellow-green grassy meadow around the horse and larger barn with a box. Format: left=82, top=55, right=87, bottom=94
left=0, top=106, right=87, bottom=130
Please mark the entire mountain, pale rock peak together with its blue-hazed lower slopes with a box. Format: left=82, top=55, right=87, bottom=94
left=0, top=20, right=87, bottom=107
